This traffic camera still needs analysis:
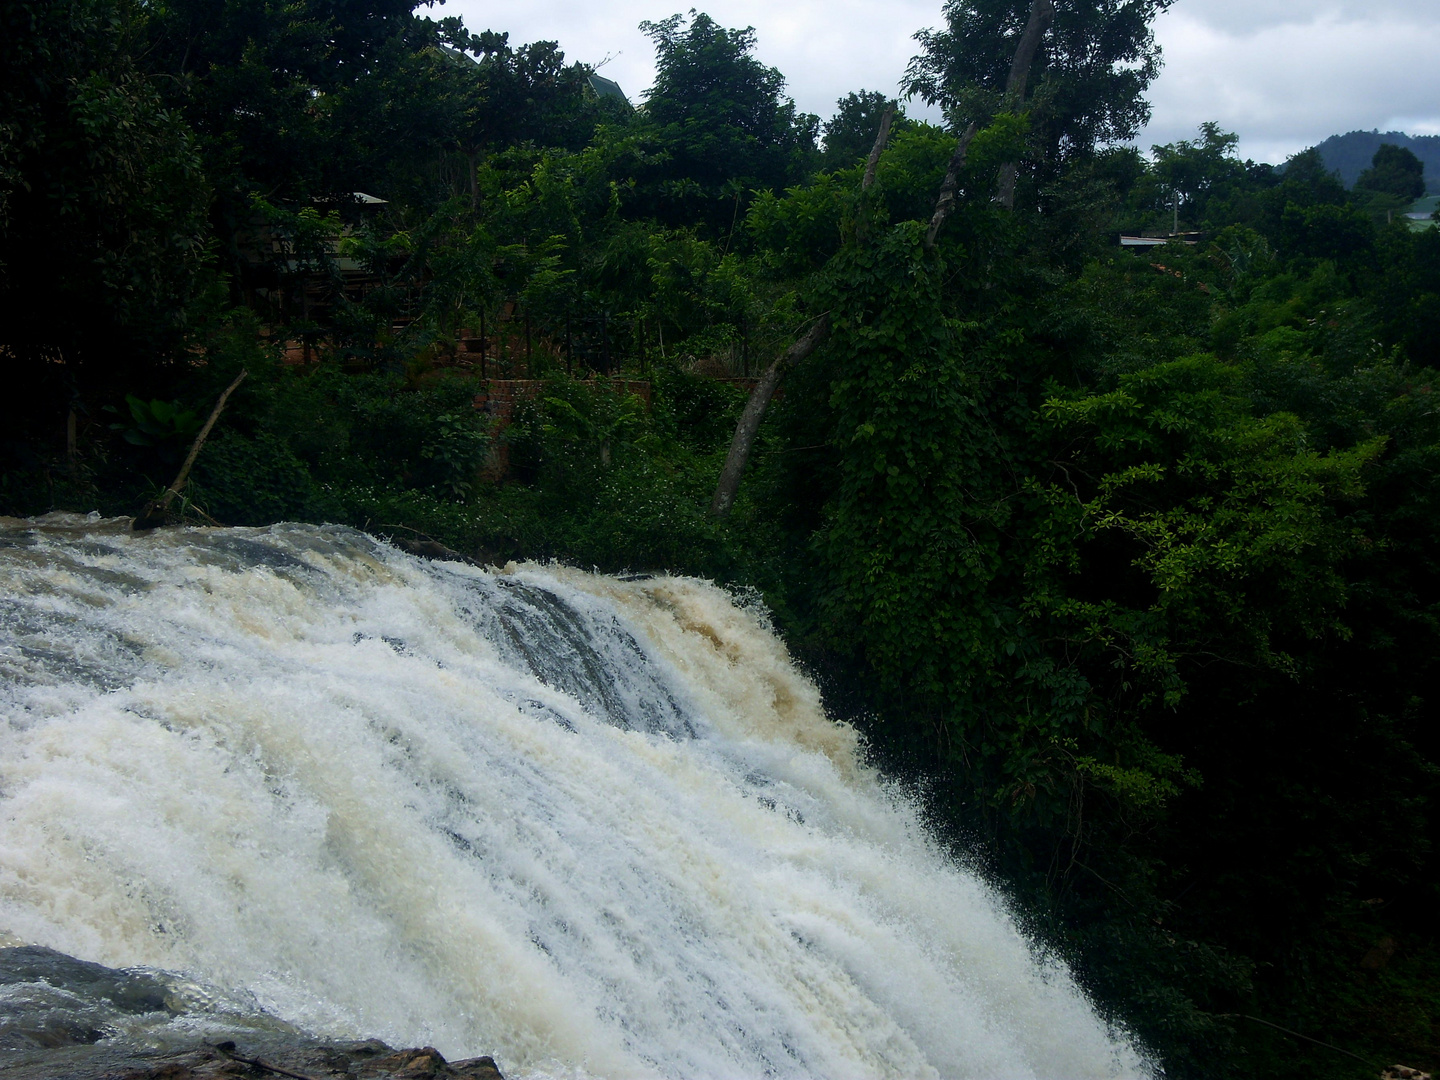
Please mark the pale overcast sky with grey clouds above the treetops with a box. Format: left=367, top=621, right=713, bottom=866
left=433, top=0, right=1440, bottom=161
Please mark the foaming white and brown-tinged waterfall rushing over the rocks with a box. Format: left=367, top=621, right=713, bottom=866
left=0, top=516, right=1149, bottom=1080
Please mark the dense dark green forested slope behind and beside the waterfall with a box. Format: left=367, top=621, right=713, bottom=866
left=0, top=0, right=1440, bottom=1080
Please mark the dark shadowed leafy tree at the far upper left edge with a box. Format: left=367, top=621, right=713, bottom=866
left=0, top=0, right=209, bottom=435
